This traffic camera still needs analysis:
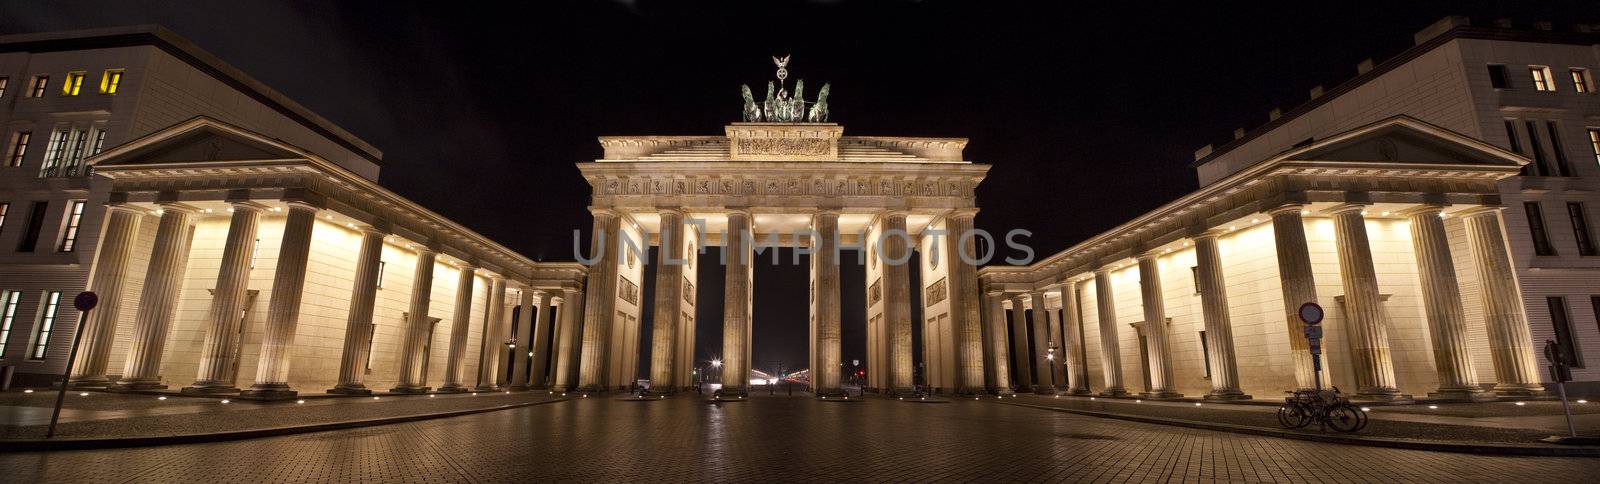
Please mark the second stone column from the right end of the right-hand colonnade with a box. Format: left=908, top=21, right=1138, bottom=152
left=1406, top=205, right=1491, bottom=399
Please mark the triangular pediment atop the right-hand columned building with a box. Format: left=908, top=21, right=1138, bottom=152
left=1285, top=119, right=1525, bottom=167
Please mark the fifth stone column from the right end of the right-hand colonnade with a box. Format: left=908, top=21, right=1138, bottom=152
left=1195, top=231, right=1250, bottom=401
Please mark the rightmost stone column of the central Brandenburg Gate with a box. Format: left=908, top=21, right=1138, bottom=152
left=944, top=208, right=985, bottom=394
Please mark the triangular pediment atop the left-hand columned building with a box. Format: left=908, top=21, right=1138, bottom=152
left=93, top=119, right=306, bottom=167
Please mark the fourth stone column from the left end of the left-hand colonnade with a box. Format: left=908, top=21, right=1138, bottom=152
left=235, top=202, right=317, bottom=399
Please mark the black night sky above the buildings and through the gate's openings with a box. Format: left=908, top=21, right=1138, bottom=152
left=0, top=0, right=1600, bottom=378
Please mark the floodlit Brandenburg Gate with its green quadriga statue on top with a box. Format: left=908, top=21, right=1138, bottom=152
left=568, top=58, right=1005, bottom=397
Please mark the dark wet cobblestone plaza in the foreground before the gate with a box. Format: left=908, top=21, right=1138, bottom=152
left=0, top=394, right=1600, bottom=482
